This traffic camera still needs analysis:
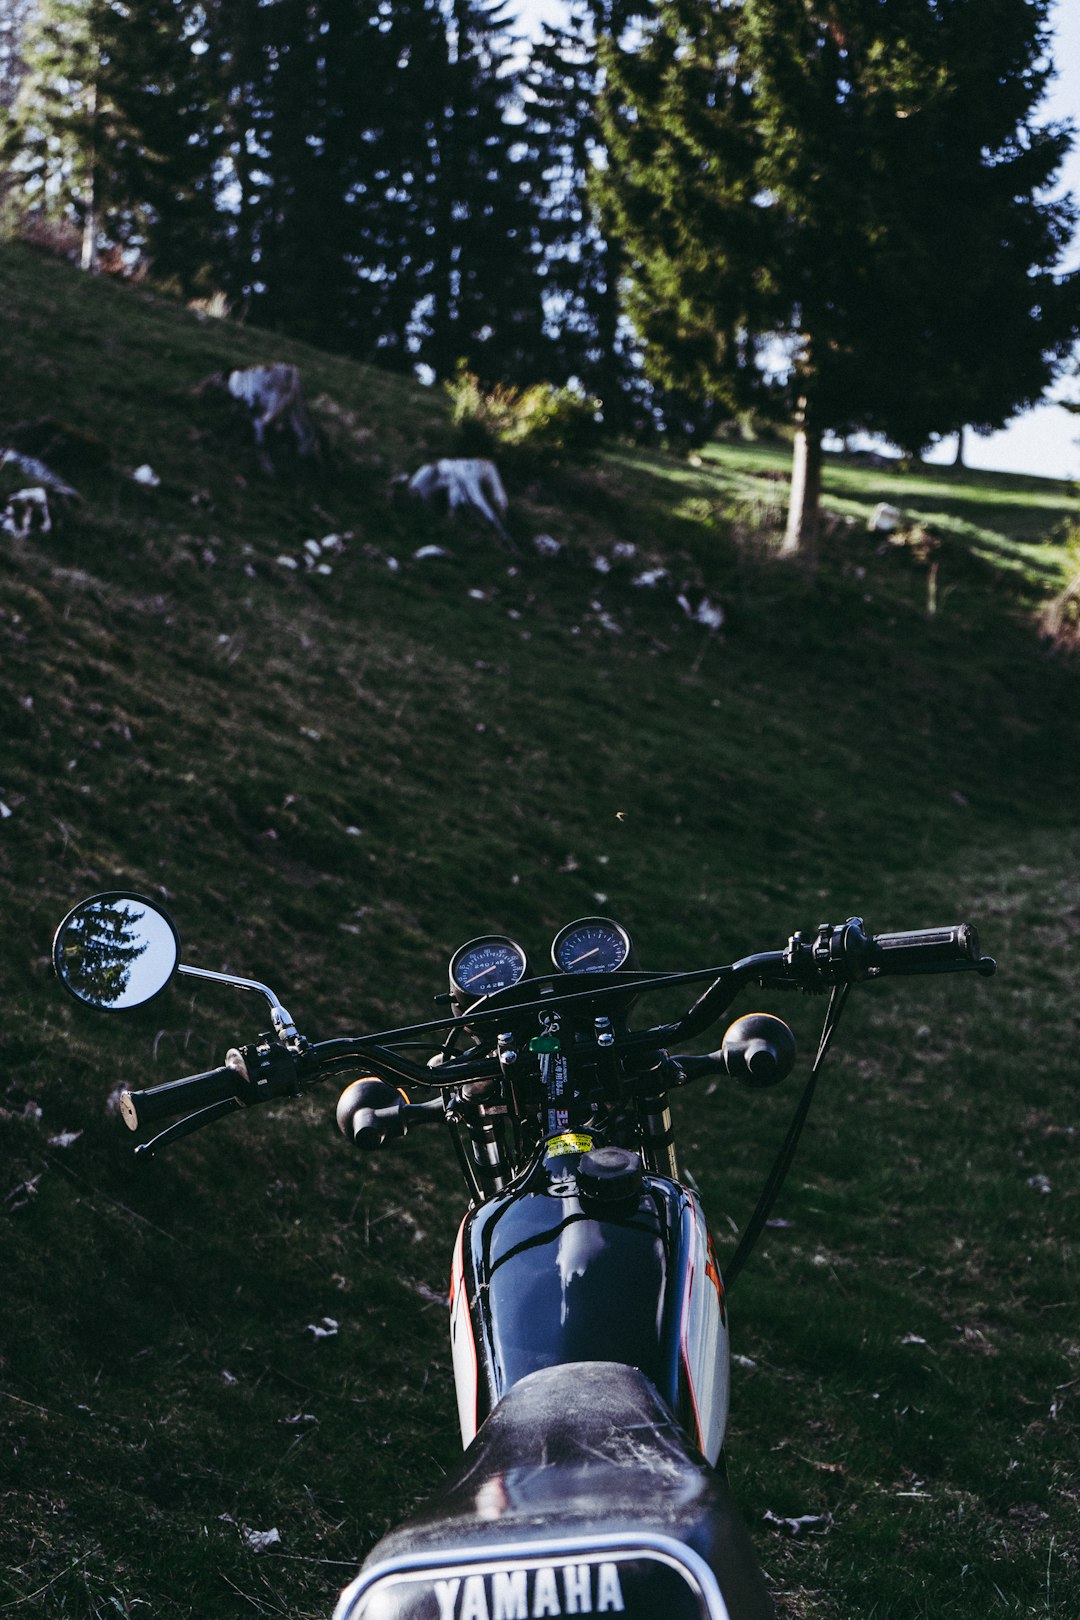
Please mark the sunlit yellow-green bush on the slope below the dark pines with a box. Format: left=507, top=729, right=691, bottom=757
left=445, top=363, right=601, bottom=462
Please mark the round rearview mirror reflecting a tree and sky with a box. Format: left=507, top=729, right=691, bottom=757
left=52, top=889, right=180, bottom=1013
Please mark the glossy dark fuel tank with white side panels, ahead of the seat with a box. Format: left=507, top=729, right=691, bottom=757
left=450, top=1139, right=729, bottom=1461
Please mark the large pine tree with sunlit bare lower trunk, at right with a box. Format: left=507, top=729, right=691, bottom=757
left=602, top=0, right=1080, bottom=549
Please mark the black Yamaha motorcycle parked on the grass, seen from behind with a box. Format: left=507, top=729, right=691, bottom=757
left=53, top=893, right=994, bottom=1620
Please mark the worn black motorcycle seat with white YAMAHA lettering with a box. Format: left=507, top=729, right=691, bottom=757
left=337, top=1361, right=772, bottom=1620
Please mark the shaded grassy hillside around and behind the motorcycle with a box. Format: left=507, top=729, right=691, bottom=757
left=0, top=248, right=1080, bottom=1620
